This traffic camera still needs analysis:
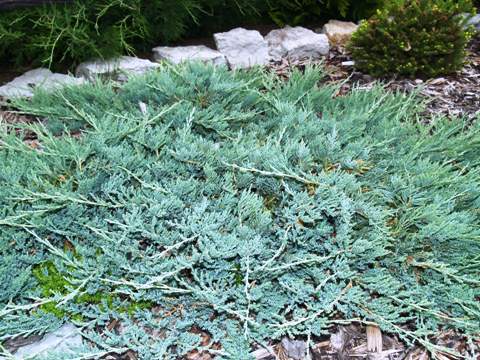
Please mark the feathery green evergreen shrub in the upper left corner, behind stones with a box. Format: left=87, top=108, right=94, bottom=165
left=0, top=0, right=262, bottom=67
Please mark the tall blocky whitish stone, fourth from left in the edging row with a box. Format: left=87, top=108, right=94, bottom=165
left=213, top=28, right=269, bottom=69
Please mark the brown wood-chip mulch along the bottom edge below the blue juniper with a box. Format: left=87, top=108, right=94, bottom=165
left=90, top=324, right=480, bottom=360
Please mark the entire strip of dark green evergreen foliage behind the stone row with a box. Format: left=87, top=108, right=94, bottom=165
left=0, top=0, right=381, bottom=69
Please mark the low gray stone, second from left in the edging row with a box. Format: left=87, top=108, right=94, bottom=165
left=75, top=56, right=160, bottom=81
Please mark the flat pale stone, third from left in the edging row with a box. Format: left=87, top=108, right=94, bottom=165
left=153, top=45, right=227, bottom=65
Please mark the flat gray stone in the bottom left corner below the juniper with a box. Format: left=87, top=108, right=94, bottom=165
left=13, top=324, right=82, bottom=359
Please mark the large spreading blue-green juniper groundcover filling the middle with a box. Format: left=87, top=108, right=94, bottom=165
left=0, top=64, right=480, bottom=359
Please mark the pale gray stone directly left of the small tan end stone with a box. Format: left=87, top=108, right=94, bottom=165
left=265, top=26, right=330, bottom=61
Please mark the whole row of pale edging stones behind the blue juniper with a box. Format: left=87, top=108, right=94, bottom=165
left=0, top=21, right=356, bottom=99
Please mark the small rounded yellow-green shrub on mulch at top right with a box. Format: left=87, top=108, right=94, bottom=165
left=350, top=0, right=472, bottom=77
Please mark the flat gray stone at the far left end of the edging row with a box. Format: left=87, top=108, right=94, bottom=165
left=0, top=68, right=85, bottom=98
